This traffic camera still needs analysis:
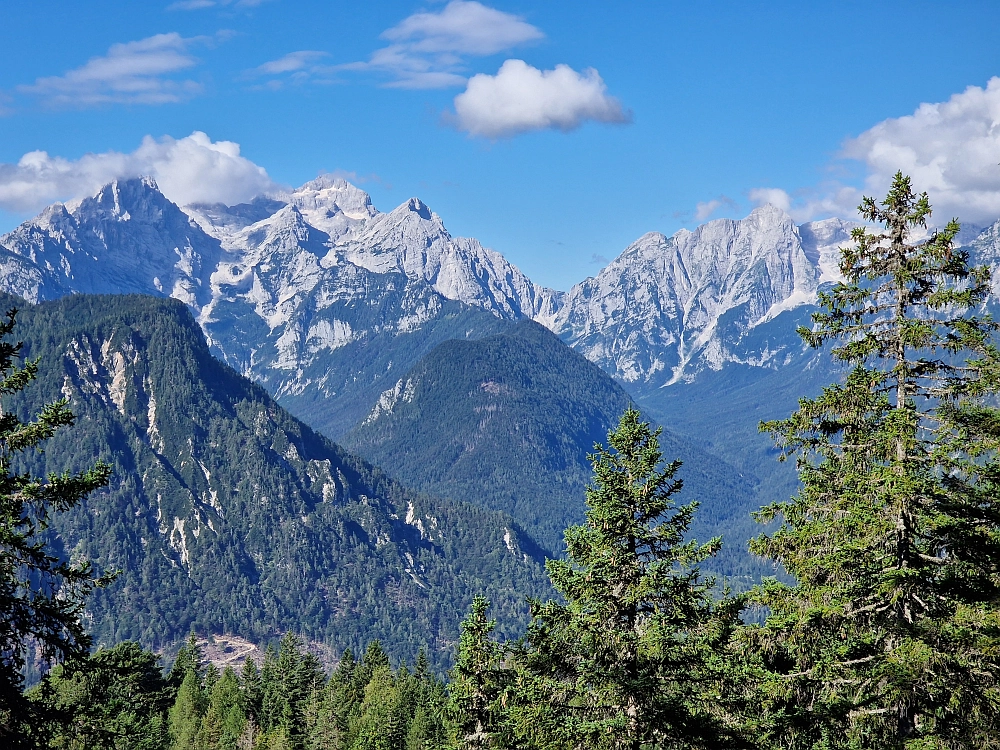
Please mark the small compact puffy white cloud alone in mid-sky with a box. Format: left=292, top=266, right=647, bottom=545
left=455, top=60, right=631, bottom=138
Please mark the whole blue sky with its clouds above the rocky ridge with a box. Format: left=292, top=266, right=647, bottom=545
left=0, top=0, right=1000, bottom=289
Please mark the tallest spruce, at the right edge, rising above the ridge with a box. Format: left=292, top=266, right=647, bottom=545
left=744, top=174, right=1000, bottom=748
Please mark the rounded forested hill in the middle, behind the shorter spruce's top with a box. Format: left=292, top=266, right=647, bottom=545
left=344, top=321, right=747, bottom=556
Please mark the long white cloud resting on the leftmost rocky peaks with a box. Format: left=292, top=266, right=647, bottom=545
left=0, top=131, right=279, bottom=213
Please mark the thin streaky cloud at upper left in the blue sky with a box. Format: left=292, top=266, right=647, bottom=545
left=18, top=32, right=204, bottom=107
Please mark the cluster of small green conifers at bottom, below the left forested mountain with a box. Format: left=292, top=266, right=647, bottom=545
left=155, top=635, right=450, bottom=750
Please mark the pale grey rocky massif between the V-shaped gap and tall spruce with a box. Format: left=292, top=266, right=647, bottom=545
left=552, top=205, right=822, bottom=385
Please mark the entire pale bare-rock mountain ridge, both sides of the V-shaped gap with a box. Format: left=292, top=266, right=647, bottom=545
left=0, top=176, right=1000, bottom=426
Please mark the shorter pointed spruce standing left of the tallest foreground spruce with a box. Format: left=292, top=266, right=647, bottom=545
left=507, top=409, right=737, bottom=750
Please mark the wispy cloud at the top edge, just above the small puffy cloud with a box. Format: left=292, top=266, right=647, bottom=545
left=338, top=0, right=545, bottom=89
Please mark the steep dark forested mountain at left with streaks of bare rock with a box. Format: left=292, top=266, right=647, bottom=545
left=0, top=295, right=545, bottom=668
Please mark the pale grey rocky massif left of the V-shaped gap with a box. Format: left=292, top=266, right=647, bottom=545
left=0, top=177, right=540, bottom=432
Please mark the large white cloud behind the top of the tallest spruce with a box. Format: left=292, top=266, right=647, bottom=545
left=750, top=77, right=1000, bottom=224
